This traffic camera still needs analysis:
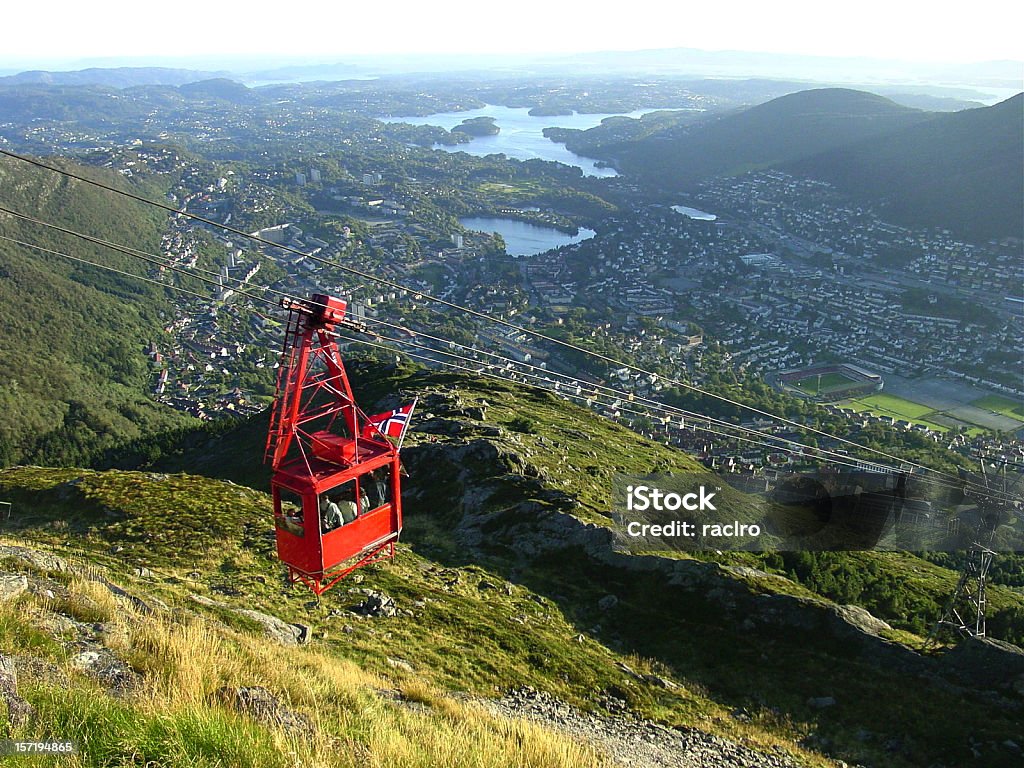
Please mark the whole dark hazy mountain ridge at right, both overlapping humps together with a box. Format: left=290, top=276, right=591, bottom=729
left=573, top=88, right=1024, bottom=240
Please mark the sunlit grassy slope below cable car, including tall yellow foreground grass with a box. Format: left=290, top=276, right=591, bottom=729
left=0, top=468, right=818, bottom=766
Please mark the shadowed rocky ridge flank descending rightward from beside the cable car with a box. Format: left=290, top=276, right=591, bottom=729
left=402, top=428, right=1024, bottom=687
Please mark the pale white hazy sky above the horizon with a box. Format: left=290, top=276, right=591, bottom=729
left=0, top=0, right=1024, bottom=67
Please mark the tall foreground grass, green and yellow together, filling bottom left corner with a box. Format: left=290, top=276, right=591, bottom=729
left=0, top=544, right=598, bottom=768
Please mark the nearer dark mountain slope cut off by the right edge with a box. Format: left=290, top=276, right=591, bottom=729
left=783, top=94, right=1024, bottom=239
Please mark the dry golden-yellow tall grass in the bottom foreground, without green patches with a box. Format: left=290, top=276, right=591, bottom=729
left=76, top=586, right=601, bottom=768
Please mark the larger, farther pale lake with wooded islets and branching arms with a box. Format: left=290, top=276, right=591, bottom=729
left=377, top=104, right=688, bottom=176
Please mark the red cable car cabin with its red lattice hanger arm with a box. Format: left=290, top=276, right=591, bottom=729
left=265, top=294, right=411, bottom=596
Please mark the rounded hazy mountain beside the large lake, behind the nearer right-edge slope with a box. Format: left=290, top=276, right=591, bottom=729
left=598, top=88, right=933, bottom=188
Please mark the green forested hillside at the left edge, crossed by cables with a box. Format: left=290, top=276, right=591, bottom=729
left=0, top=160, right=194, bottom=465
